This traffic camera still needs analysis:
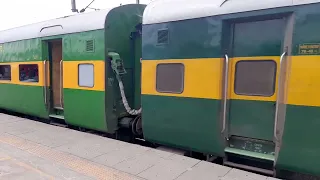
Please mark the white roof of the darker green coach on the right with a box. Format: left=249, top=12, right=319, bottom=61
left=143, top=0, right=320, bottom=24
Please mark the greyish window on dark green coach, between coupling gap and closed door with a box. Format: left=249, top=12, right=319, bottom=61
left=156, top=63, right=184, bottom=94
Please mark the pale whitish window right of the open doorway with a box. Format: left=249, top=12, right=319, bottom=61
left=78, top=64, right=94, bottom=88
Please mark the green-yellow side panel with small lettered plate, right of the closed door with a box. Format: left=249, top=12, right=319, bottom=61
left=277, top=4, right=320, bottom=176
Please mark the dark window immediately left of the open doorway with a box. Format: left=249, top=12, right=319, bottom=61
left=19, top=64, right=39, bottom=82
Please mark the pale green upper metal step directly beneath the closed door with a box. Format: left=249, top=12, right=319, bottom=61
left=224, top=147, right=275, bottom=161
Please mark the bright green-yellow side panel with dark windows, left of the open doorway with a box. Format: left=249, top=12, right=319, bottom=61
left=0, top=39, right=47, bottom=117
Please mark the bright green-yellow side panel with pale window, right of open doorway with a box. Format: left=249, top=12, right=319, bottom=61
left=63, top=30, right=107, bottom=131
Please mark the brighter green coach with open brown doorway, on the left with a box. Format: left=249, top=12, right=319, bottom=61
left=0, top=4, right=145, bottom=133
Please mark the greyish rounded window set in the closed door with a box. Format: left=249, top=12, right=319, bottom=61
left=234, top=60, right=277, bottom=96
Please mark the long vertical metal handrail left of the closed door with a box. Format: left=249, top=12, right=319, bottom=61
left=221, top=54, right=229, bottom=133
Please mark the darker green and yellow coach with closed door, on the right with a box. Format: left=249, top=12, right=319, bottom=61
left=141, top=0, right=320, bottom=179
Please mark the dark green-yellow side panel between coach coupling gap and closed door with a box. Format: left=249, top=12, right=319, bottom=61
left=141, top=18, right=224, bottom=156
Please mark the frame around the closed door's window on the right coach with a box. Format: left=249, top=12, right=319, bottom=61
left=233, top=59, right=278, bottom=97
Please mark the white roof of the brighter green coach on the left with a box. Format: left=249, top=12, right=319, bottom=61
left=0, top=9, right=110, bottom=43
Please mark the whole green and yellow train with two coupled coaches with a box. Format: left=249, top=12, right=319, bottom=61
left=0, top=0, right=320, bottom=180
